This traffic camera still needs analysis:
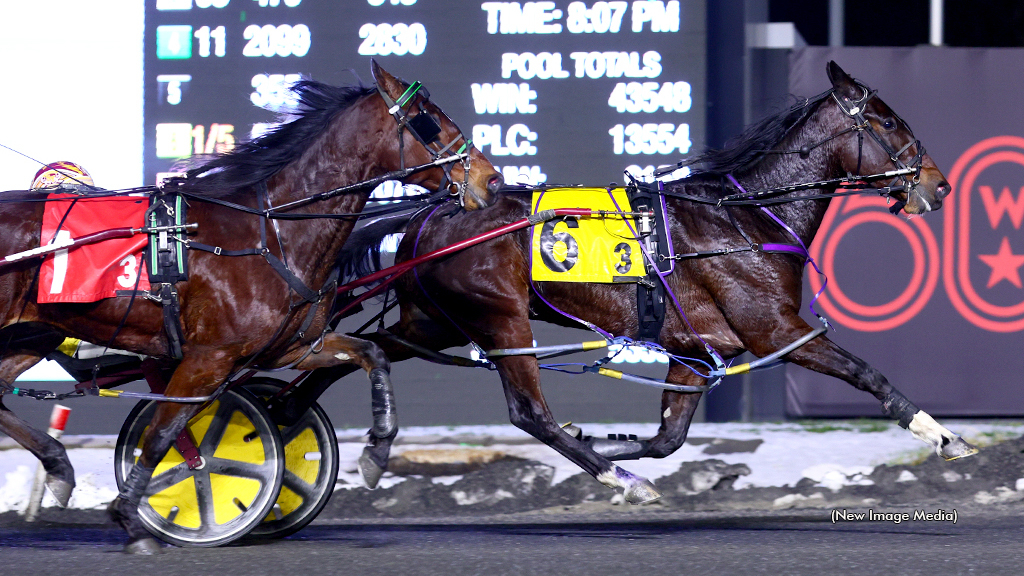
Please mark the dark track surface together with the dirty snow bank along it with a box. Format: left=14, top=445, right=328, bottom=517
left=0, top=439, right=1024, bottom=576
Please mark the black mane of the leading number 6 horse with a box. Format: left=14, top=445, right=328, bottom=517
left=684, top=90, right=831, bottom=179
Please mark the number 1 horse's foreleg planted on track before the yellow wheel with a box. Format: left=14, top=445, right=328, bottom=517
left=106, top=345, right=240, bottom=554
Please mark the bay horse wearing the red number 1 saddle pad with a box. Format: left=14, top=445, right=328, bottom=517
left=0, top=61, right=503, bottom=553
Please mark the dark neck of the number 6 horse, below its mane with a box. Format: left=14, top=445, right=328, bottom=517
left=733, top=112, right=845, bottom=246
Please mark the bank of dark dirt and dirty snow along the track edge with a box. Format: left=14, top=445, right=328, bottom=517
left=309, top=438, right=1024, bottom=520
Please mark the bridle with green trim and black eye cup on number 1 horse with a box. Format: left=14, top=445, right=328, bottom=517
left=377, top=82, right=473, bottom=207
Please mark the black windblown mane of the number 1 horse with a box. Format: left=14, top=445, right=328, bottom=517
left=182, top=80, right=375, bottom=197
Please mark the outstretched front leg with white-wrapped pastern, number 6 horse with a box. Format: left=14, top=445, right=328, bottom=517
left=751, top=320, right=978, bottom=460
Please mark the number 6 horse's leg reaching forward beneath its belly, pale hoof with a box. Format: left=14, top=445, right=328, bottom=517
left=495, top=352, right=662, bottom=504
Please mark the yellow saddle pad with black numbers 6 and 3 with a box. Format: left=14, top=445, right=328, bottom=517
left=530, top=188, right=647, bottom=283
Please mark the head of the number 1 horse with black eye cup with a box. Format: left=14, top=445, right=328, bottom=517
left=371, top=60, right=505, bottom=210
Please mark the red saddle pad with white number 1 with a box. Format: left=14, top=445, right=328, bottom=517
left=39, top=194, right=150, bottom=303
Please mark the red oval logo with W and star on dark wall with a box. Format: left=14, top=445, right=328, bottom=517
left=942, top=136, right=1024, bottom=332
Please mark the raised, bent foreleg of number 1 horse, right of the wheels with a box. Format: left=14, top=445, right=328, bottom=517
left=295, top=332, right=398, bottom=488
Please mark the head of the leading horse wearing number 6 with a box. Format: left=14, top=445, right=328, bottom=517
left=827, top=61, right=950, bottom=214
